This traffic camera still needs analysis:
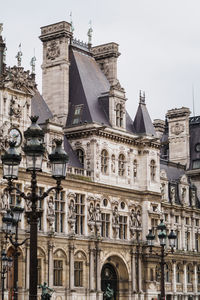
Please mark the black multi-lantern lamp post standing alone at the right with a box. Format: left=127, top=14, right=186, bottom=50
left=146, top=220, right=177, bottom=300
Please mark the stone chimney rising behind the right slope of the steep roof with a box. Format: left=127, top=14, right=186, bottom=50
left=91, top=43, right=120, bottom=86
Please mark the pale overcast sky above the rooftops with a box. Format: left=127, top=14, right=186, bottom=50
left=0, top=0, right=200, bottom=119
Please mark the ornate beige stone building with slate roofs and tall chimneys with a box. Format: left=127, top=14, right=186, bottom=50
left=0, top=21, right=200, bottom=300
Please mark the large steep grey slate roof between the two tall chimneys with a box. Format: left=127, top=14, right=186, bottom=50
left=67, top=47, right=134, bottom=132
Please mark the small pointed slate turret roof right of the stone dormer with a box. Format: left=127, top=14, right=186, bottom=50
left=133, top=97, right=156, bottom=136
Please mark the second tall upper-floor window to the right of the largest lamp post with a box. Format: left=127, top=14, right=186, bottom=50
left=75, top=194, right=85, bottom=235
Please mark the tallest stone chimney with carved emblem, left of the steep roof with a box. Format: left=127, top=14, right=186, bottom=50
left=40, top=21, right=72, bottom=126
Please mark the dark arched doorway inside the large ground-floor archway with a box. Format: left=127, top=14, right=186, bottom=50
left=101, top=263, right=118, bottom=300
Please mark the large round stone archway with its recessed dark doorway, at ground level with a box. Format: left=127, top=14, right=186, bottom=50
left=101, top=255, right=129, bottom=300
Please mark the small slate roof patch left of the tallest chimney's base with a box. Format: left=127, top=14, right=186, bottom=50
left=31, top=92, right=53, bottom=124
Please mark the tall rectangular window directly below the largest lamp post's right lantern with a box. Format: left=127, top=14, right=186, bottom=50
left=54, top=191, right=65, bottom=233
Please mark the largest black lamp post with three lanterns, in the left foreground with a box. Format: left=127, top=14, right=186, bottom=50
left=1, top=116, right=68, bottom=300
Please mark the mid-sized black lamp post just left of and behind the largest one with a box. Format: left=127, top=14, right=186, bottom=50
left=2, top=203, right=28, bottom=300
